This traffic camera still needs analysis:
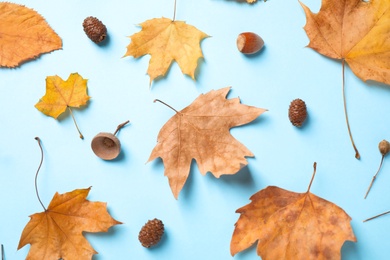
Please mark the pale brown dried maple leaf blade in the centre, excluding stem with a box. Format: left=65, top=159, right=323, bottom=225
left=148, top=88, right=266, bottom=198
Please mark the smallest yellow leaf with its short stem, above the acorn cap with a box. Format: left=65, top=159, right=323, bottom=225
left=35, top=73, right=90, bottom=138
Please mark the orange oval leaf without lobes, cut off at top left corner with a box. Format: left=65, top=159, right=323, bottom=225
left=0, top=3, right=62, bottom=67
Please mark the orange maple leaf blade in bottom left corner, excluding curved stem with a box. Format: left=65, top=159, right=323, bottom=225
left=18, top=188, right=121, bottom=260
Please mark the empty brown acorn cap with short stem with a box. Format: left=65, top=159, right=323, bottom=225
left=91, top=120, right=130, bottom=160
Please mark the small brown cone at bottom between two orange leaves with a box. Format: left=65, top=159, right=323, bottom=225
left=138, top=218, right=164, bottom=247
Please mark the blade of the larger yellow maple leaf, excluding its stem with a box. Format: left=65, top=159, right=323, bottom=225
left=124, top=18, right=208, bottom=82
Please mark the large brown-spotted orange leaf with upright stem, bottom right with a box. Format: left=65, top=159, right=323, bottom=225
left=230, top=164, right=356, bottom=260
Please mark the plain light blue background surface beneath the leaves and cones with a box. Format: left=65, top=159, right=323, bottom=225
left=0, top=0, right=390, bottom=260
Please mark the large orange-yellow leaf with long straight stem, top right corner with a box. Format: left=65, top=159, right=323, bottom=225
left=301, top=0, right=390, bottom=159
